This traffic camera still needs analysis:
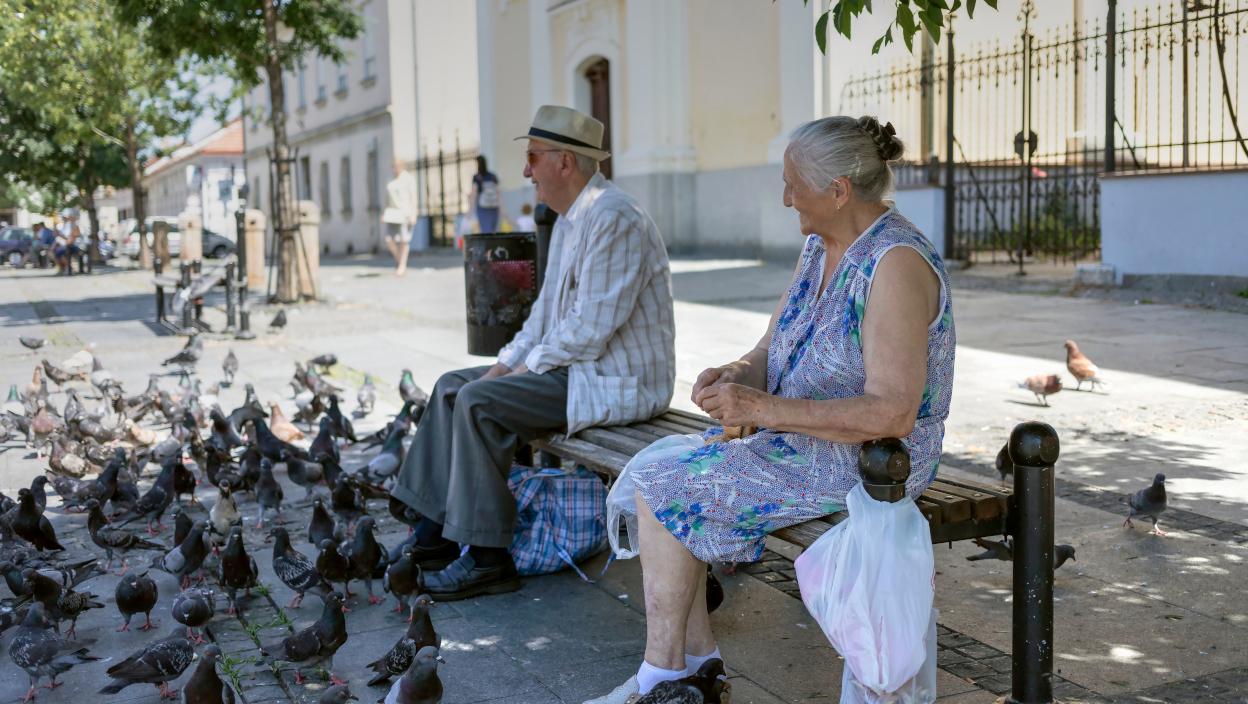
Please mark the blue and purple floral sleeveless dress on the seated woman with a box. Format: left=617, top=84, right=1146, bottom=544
left=633, top=210, right=955, bottom=562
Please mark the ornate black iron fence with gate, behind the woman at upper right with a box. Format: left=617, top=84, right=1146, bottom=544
left=840, top=0, right=1248, bottom=265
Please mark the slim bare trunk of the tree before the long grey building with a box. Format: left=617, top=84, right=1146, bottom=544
left=261, top=0, right=301, bottom=303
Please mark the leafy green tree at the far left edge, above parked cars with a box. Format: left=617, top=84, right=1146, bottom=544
left=0, top=0, right=196, bottom=259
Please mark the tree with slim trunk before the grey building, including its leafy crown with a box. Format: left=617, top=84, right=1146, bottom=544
left=116, top=0, right=363, bottom=302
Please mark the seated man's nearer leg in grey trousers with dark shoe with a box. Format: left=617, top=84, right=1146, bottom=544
left=424, top=368, right=568, bottom=600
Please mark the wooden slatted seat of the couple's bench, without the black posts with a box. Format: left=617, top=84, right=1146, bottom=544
left=533, top=411, right=1010, bottom=548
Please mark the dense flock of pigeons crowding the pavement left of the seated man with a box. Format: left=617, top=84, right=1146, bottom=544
left=0, top=336, right=501, bottom=704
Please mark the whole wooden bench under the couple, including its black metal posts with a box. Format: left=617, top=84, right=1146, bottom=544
left=533, top=411, right=1060, bottom=703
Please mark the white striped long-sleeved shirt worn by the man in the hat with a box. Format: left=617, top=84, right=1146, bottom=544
left=498, top=174, right=676, bottom=433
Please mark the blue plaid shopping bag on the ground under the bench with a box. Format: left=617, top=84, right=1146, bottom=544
left=507, top=464, right=607, bottom=582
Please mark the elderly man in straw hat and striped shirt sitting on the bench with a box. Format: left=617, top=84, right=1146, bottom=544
left=393, top=105, right=675, bottom=600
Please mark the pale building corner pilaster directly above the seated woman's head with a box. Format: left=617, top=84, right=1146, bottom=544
left=768, top=2, right=827, bottom=164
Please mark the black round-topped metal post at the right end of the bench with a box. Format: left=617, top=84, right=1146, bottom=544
left=1008, top=421, right=1060, bottom=704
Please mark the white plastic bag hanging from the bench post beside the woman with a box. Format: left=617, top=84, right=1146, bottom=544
left=794, top=483, right=935, bottom=704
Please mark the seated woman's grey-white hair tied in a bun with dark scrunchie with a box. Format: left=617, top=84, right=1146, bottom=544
left=787, top=115, right=905, bottom=202
